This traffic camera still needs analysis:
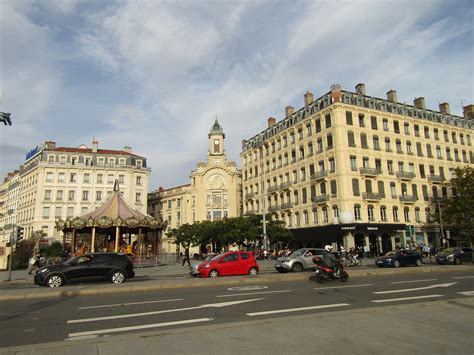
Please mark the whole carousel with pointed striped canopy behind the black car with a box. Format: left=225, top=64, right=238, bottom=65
left=56, top=181, right=166, bottom=262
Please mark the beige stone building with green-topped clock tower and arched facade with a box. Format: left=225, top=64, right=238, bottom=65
left=148, top=119, right=242, bottom=253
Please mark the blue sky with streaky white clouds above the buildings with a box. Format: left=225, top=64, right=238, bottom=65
left=0, top=0, right=474, bottom=190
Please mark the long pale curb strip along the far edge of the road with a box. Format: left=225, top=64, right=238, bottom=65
left=0, top=265, right=474, bottom=301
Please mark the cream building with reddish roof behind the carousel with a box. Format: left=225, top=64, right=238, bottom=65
left=7, top=141, right=150, bottom=241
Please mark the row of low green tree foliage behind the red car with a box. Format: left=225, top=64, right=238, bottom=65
left=168, top=215, right=293, bottom=252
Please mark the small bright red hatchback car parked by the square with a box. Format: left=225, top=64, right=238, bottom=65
left=198, top=251, right=259, bottom=278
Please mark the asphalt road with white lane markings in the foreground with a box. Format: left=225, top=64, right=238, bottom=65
left=0, top=272, right=474, bottom=347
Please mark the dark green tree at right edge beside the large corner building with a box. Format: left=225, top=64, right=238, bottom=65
left=441, top=166, right=474, bottom=242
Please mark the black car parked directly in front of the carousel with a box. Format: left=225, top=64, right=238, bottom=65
left=35, top=253, right=135, bottom=287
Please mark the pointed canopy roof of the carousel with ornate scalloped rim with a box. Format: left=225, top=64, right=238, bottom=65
left=56, top=180, right=167, bottom=230
